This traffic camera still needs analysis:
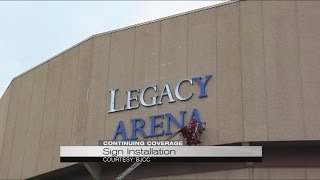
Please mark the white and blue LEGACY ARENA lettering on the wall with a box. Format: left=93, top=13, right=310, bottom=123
left=108, top=75, right=212, bottom=140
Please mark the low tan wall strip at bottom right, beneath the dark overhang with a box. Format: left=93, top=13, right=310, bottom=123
left=149, top=168, right=320, bottom=179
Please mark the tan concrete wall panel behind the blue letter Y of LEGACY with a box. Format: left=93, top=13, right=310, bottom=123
left=187, top=8, right=218, bottom=145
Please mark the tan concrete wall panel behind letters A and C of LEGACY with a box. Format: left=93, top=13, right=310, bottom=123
left=158, top=15, right=190, bottom=139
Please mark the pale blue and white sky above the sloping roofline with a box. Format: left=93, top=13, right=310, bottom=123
left=0, top=0, right=224, bottom=97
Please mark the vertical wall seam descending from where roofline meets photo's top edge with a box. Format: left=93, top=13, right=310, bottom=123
left=238, top=1, right=245, bottom=141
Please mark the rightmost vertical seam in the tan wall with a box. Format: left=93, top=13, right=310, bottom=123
left=295, top=1, right=308, bottom=139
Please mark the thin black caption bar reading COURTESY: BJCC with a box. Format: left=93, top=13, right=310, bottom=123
left=60, top=157, right=262, bottom=163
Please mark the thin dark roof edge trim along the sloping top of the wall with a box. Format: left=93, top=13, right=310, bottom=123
left=9, top=0, right=236, bottom=80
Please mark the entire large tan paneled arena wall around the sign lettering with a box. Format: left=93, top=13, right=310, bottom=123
left=0, top=1, right=320, bottom=178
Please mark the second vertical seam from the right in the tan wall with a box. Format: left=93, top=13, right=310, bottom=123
left=260, top=1, right=270, bottom=140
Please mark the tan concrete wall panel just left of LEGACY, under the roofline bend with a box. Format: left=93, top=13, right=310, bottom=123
left=85, top=35, right=110, bottom=145
